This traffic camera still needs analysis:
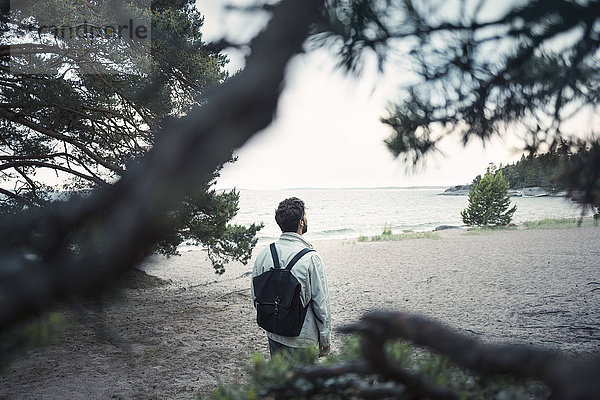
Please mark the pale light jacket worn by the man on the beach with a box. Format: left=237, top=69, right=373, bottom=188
left=250, top=232, right=331, bottom=347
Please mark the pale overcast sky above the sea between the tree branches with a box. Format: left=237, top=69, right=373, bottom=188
left=192, top=0, right=568, bottom=189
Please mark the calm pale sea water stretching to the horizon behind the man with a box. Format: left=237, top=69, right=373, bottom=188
left=234, top=188, right=592, bottom=243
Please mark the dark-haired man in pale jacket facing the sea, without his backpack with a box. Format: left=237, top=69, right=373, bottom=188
left=251, top=197, right=331, bottom=356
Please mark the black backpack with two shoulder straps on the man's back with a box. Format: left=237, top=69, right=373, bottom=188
left=252, top=243, right=314, bottom=336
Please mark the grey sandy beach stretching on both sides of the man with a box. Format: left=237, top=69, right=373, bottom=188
left=0, top=227, right=600, bottom=399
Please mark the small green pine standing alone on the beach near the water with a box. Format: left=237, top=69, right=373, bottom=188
left=460, top=167, right=517, bottom=226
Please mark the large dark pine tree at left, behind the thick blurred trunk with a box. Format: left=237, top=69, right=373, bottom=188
left=0, top=0, right=262, bottom=273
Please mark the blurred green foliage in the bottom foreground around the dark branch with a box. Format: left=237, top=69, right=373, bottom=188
left=210, top=336, right=549, bottom=400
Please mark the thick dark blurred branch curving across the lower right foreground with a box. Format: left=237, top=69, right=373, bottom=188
left=341, top=311, right=600, bottom=399
